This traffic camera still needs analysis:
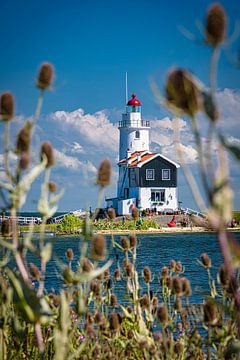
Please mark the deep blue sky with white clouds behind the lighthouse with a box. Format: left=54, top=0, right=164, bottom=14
left=0, top=0, right=240, bottom=210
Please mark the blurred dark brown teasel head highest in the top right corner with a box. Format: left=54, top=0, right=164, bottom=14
left=205, top=3, right=227, bottom=47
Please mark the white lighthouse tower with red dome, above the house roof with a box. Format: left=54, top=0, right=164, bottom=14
left=118, top=94, right=150, bottom=160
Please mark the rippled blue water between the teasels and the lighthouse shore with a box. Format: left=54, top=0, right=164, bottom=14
left=24, top=233, right=240, bottom=303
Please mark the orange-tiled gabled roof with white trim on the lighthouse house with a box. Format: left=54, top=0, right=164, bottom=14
left=118, top=151, right=180, bottom=168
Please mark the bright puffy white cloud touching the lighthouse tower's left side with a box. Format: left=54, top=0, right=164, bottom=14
left=51, top=109, right=119, bottom=153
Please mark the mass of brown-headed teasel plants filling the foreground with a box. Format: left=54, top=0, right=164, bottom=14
left=0, top=4, right=240, bottom=360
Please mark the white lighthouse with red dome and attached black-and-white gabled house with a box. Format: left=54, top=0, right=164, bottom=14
left=106, top=94, right=179, bottom=215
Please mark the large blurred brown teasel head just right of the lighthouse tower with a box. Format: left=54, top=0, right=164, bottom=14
left=165, top=69, right=201, bottom=116
